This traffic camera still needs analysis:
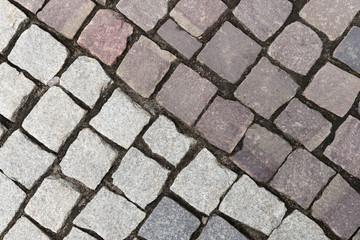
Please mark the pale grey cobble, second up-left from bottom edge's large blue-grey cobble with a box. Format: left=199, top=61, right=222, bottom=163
left=60, top=128, right=117, bottom=189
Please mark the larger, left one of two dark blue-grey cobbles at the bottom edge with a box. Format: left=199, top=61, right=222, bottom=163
left=139, top=197, right=200, bottom=240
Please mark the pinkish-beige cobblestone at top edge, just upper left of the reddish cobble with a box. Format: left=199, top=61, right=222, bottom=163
left=37, top=0, right=95, bottom=39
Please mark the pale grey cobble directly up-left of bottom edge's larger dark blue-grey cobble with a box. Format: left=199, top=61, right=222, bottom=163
left=112, top=148, right=169, bottom=208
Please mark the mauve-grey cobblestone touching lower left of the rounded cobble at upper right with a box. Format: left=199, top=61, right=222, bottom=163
left=234, top=58, right=299, bottom=119
